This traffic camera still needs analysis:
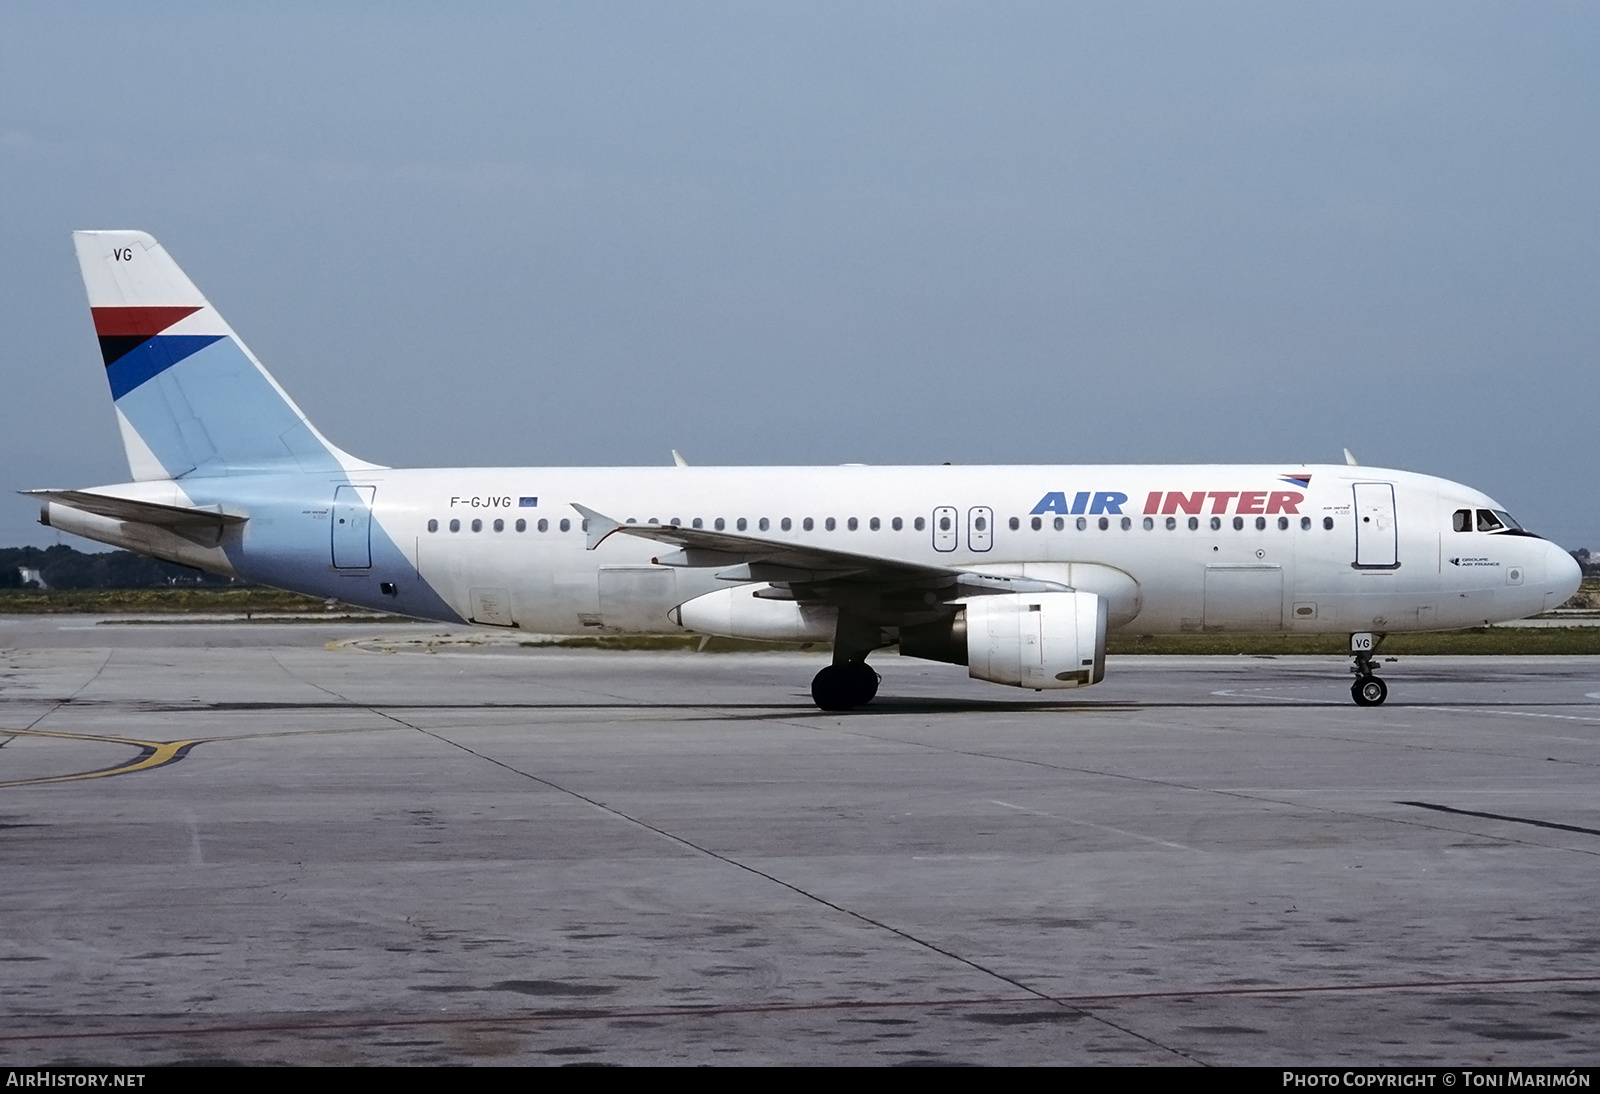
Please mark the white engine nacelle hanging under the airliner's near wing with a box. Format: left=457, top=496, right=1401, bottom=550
left=965, top=592, right=1106, bottom=689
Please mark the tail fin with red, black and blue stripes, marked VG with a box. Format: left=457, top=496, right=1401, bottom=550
left=72, top=232, right=374, bottom=481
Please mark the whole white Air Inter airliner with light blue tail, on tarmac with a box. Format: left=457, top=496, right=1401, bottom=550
left=29, top=232, right=1579, bottom=710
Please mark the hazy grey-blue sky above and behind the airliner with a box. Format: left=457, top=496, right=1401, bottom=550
left=0, top=3, right=1600, bottom=549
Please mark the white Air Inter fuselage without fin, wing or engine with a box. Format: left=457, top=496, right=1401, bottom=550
left=51, top=465, right=1576, bottom=635
